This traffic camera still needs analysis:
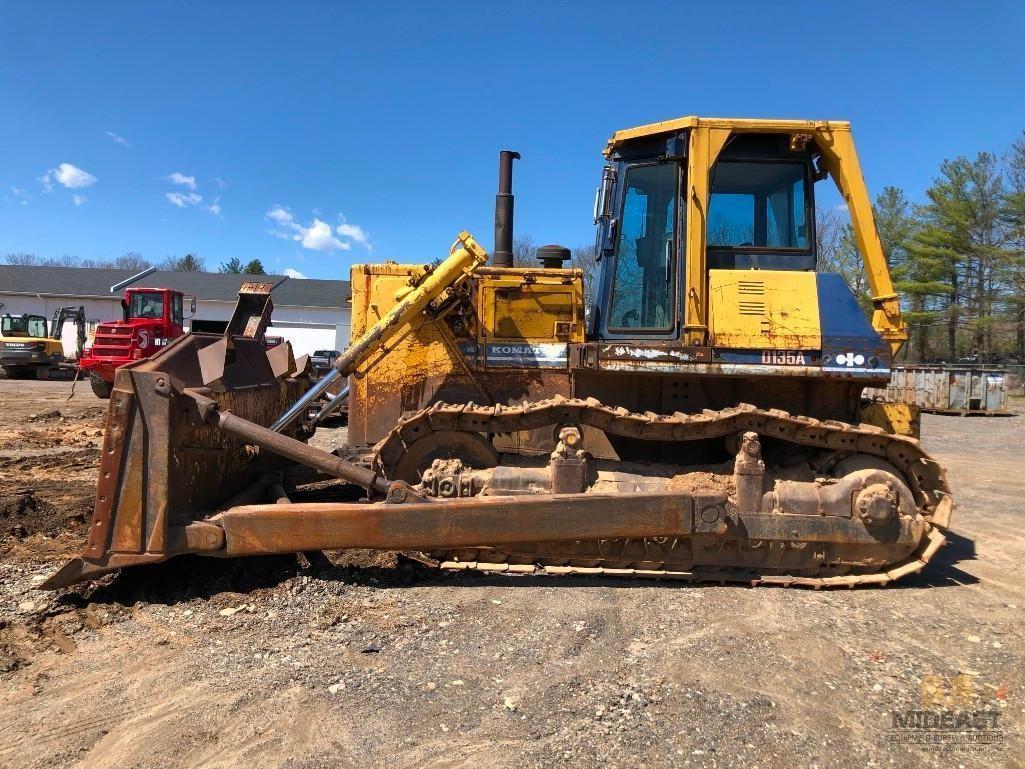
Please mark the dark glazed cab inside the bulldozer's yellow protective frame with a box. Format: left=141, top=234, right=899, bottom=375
left=590, top=131, right=823, bottom=340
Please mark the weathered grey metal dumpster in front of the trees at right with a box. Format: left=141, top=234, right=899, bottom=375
left=863, top=365, right=1009, bottom=415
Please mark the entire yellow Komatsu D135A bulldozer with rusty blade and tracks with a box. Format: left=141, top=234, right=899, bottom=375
left=46, top=117, right=953, bottom=588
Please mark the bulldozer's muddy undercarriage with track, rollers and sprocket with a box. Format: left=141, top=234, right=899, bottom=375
left=375, top=399, right=952, bottom=586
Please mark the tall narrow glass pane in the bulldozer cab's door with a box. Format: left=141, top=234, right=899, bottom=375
left=608, top=163, right=677, bottom=331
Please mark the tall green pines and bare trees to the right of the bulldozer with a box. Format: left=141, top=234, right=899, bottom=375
left=816, top=133, right=1025, bottom=363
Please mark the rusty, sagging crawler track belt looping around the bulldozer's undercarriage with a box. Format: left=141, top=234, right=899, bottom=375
left=375, top=398, right=953, bottom=589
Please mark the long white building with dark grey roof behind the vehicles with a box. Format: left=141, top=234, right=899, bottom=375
left=0, top=265, right=351, bottom=355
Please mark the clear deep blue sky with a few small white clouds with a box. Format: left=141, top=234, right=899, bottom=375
left=0, top=0, right=1025, bottom=278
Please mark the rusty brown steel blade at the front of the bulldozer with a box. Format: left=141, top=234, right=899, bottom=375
left=42, top=333, right=309, bottom=588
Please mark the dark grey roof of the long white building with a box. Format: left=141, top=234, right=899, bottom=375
left=0, top=265, right=350, bottom=308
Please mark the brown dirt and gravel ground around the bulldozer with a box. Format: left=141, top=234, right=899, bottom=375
left=0, top=381, right=1025, bottom=769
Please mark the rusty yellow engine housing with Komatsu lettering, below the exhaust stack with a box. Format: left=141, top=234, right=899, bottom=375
left=349, top=265, right=584, bottom=450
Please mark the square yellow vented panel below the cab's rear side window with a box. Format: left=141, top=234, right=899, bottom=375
left=708, top=270, right=822, bottom=350
